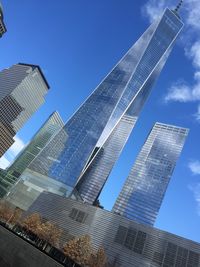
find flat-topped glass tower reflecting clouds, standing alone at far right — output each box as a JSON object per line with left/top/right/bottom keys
{"left": 113, "top": 123, "right": 188, "bottom": 225}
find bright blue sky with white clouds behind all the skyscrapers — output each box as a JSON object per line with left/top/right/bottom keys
{"left": 0, "top": 0, "right": 200, "bottom": 242}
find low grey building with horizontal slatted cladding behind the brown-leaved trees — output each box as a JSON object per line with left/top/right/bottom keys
{"left": 28, "top": 192, "right": 200, "bottom": 267}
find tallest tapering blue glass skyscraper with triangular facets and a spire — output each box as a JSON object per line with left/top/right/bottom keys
{"left": 26, "top": 9, "right": 183, "bottom": 199}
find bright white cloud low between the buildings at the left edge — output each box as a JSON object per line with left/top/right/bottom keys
{"left": 0, "top": 136, "right": 25, "bottom": 169}
